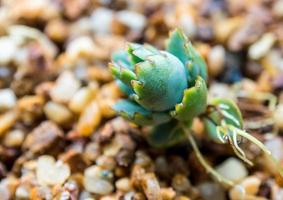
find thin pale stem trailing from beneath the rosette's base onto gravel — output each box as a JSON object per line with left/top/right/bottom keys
{"left": 182, "top": 125, "right": 234, "bottom": 187}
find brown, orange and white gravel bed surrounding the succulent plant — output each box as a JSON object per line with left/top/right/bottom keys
{"left": 0, "top": 0, "right": 283, "bottom": 200}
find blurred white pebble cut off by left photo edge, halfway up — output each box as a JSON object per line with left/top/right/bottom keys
{"left": 0, "top": 89, "right": 17, "bottom": 112}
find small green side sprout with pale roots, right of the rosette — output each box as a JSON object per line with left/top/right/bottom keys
{"left": 203, "top": 99, "right": 283, "bottom": 176}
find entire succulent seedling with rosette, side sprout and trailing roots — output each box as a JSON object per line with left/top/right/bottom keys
{"left": 110, "top": 29, "right": 283, "bottom": 185}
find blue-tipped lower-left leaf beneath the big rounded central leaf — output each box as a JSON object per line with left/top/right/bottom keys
{"left": 113, "top": 100, "right": 171, "bottom": 125}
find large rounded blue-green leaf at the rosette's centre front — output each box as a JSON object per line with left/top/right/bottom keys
{"left": 132, "top": 51, "right": 187, "bottom": 111}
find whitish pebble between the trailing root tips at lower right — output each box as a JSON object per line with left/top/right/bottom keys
{"left": 216, "top": 158, "right": 248, "bottom": 182}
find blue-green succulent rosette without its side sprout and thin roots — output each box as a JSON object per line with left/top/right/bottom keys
{"left": 110, "top": 29, "right": 207, "bottom": 147}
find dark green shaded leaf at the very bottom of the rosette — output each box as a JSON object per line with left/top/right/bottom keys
{"left": 147, "top": 120, "right": 189, "bottom": 148}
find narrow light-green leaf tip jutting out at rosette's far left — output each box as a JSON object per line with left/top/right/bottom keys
{"left": 109, "top": 63, "right": 137, "bottom": 86}
